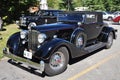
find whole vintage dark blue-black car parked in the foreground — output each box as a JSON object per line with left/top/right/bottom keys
{"left": 3, "top": 11, "right": 116, "bottom": 76}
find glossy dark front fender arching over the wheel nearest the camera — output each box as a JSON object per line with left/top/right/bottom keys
{"left": 35, "top": 38, "right": 71, "bottom": 59}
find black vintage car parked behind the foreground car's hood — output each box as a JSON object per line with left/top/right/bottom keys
{"left": 17, "top": 10, "right": 62, "bottom": 29}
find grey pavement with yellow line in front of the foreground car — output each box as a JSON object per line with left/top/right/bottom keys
{"left": 0, "top": 22, "right": 120, "bottom": 80}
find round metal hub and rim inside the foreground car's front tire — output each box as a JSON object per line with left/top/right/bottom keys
{"left": 50, "top": 52, "right": 65, "bottom": 70}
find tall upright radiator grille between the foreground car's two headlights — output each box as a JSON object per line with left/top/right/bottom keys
{"left": 28, "top": 30, "right": 39, "bottom": 52}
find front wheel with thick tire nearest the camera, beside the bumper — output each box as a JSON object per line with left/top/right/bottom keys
{"left": 45, "top": 47, "right": 69, "bottom": 76}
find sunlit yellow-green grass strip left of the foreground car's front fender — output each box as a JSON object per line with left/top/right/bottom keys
{"left": 0, "top": 24, "right": 20, "bottom": 59}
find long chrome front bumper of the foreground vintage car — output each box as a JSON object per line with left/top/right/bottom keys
{"left": 3, "top": 48, "right": 45, "bottom": 73}
